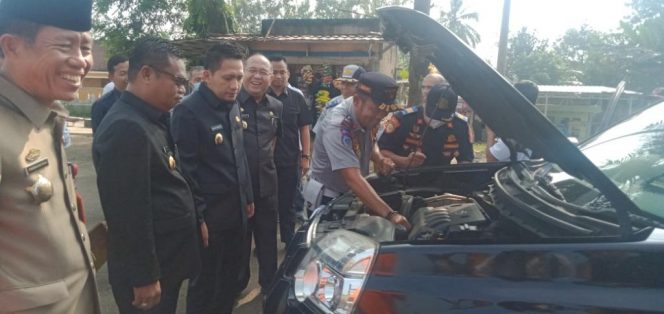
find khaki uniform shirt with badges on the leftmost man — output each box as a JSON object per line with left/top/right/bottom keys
{"left": 0, "top": 75, "right": 100, "bottom": 314}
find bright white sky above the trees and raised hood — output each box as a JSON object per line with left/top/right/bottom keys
{"left": 431, "top": 0, "right": 631, "bottom": 64}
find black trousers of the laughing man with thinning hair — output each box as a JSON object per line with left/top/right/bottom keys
{"left": 240, "top": 195, "right": 278, "bottom": 292}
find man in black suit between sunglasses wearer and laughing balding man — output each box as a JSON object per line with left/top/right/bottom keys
{"left": 172, "top": 43, "right": 254, "bottom": 314}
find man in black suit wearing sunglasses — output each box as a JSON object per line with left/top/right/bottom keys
{"left": 92, "top": 38, "right": 200, "bottom": 313}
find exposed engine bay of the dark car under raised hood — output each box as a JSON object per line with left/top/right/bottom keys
{"left": 314, "top": 163, "right": 643, "bottom": 244}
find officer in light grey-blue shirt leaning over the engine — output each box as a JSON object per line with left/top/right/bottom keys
{"left": 305, "top": 72, "right": 410, "bottom": 228}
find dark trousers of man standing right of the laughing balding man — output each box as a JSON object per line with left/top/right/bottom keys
{"left": 277, "top": 166, "right": 299, "bottom": 244}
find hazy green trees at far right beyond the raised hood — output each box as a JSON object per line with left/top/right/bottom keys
{"left": 507, "top": 0, "right": 664, "bottom": 93}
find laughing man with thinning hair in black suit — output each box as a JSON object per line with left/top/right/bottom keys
{"left": 238, "top": 54, "right": 283, "bottom": 293}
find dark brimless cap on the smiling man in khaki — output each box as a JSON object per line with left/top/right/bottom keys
{"left": 0, "top": 0, "right": 92, "bottom": 32}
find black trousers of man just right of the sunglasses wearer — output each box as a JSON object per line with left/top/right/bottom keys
{"left": 187, "top": 226, "right": 244, "bottom": 314}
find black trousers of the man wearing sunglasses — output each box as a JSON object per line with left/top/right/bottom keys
{"left": 111, "top": 279, "right": 183, "bottom": 314}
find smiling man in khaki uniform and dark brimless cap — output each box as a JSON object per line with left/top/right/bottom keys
{"left": 0, "top": 0, "right": 100, "bottom": 314}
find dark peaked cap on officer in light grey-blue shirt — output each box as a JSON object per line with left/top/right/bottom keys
{"left": 357, "top": 72, "right": 401, "bottom": 112}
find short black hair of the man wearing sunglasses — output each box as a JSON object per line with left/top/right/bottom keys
{"left": 129, "top": 36, "right": 182, "bottom": 82}
